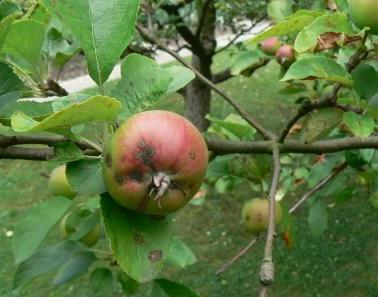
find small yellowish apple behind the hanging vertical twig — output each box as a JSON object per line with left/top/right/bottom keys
{"left": 241, "top": 198, "right": 282, "bottom": 233}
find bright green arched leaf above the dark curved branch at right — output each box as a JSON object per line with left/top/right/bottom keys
{"left": 281, "top": 56, "right": 353, "bottom": 86}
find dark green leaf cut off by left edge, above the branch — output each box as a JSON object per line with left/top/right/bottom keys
{"left": 0, "top": 62, "right": 25, "bottom": 108}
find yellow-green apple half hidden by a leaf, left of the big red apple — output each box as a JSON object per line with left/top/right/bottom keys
{"left": 47, "top": 164, "right": 76, "bottom": 199}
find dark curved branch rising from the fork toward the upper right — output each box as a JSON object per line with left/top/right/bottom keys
{"left": 278, "top": 33, "right": 368, "bottom": 143}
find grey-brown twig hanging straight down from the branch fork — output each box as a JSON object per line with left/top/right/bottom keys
{"left": 259, "top": 146, "right": 281, "bottom": 297}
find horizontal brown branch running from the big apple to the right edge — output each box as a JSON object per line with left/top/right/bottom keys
{"left": 206, "top": 136, "right": 378, "bottom": 154}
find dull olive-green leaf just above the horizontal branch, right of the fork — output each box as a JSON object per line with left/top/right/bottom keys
{"left": 304, "top": 108, "right": 343, "bottom": 143}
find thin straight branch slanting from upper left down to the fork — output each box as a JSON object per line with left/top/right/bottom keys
{"left": 136, "top": 24, "right": 276, "bottom": 139}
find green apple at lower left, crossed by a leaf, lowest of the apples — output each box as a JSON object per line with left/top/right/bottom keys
{"left": 59, "top": 208, "right": 100, "bottom": 247}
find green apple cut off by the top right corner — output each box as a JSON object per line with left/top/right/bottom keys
{"left": 348, "top": 0, "right": 378, "bottom": 35}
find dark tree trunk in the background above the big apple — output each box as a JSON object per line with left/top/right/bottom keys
{"left": 185, "top": 1, "right": 216, "bottom": 131}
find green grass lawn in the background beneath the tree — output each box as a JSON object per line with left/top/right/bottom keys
{"left": 0, "top": 51, "right": 378, "bottom": 297}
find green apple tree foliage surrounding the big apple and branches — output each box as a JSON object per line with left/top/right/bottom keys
{"left": 0, "top": 0, "right": 378, "bottom": 297}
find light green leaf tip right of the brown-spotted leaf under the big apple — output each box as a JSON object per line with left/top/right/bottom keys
{"left": 167, "top": 237, "right": 197, "bottom": 268}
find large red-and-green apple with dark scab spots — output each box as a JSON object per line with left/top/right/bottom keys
{"left": 103, "top": 110, "right": 208, "bottom": 215}
